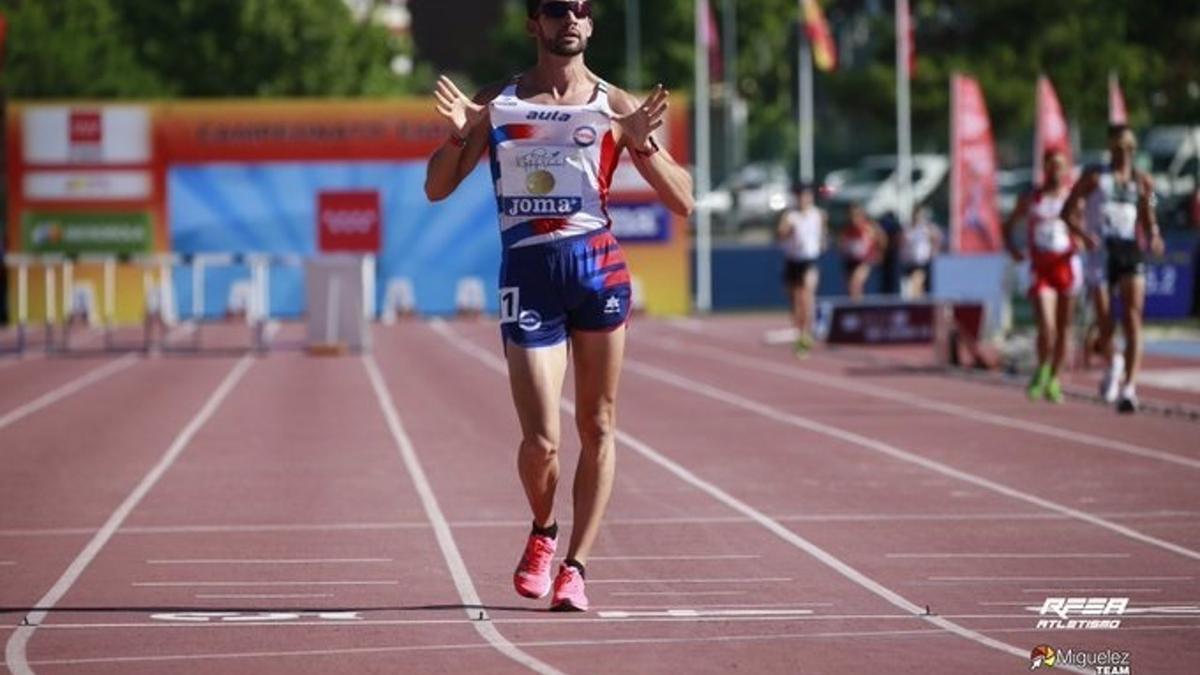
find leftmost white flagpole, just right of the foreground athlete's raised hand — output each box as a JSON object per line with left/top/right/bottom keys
{"left": 692, "top": 0, "right": 713, "bottom": 312}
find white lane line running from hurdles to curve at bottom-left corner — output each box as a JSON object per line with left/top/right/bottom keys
{"left": 5, "top": 356, "right": 254, "bottom": 675}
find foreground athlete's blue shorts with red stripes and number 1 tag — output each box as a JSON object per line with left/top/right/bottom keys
{"left": 500, "top": 229, "right": 632, "bottom": 348}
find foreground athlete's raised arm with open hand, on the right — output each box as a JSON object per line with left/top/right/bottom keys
{"left": 608, "top": 84, "right": 696, "bottom": 215}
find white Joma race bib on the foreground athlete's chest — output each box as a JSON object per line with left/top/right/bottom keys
{"left": 500, "top": 145, "right": 587, "bottom": 217}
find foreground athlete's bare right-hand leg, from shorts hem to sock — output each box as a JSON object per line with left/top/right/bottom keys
{"left": 566, "top": 327, "right": 625, "bottom": 565}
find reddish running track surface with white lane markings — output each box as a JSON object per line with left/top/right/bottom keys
{"left": 0, "top": 318, "right": 1200, "bottom": 674}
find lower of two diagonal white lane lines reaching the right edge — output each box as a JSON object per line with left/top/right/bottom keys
{"left": 625, "top": 360, "right": 1200, "bottom": 560}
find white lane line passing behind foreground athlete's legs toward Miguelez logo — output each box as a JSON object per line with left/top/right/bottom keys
{"left": 431, "top": 319, "right": 1086, "bottom": 673}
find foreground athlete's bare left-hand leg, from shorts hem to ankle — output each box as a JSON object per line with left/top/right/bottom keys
{"left": 505, "top": 342, "right": 566, "bottom": 527}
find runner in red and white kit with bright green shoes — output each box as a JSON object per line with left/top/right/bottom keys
{"left": 1004, "top": 150, "right": 1081, "bottom": 404}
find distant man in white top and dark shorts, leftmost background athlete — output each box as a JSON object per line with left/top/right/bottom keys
{"left": 778, "top": 185, "right": 829, "bottom": 356}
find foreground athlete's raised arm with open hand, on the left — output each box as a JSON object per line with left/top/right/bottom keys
{"left": 425, "top": 76, "right": 504, "bottom": 202}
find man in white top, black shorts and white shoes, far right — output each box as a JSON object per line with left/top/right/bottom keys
{"left": 1062, "top": 125, "right": 1163, "bottom": 413}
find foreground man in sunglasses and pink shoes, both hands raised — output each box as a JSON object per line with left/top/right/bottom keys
{"left": 425, "top": 0, "right": 694, "bottom": 611}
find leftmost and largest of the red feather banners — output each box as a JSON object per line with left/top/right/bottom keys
{"left": 950, "top": 74, "right": 1001, "bottom": 253}
